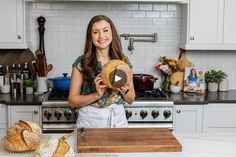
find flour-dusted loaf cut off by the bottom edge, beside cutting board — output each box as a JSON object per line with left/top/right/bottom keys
{"left": 35, "top": 139, "right": 75, "bottom": 157}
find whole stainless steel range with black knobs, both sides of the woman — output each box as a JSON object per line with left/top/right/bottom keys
{"left": 42, "top": 89, "right": 174, "bottom": 133}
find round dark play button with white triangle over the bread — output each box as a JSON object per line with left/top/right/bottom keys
{"left": 109, "top": 69, "right": 127, "bottom": 88}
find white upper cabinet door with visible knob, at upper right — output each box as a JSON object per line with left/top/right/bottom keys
{"left": 187, "top": 0, "right": 223, "bottom": 44}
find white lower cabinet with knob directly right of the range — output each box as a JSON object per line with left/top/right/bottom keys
{"left": 174, "top": 105, "right": 203, "bottom": 133}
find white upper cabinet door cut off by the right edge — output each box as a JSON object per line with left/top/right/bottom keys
{"left": 223, "top": 0, "right": 236, "bottom": 44}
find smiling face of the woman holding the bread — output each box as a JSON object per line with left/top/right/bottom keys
{"left": 91, "top": 20, "right": 112, "bottom": 49}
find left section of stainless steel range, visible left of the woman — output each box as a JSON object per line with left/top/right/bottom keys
{"left": 42, "top": 90, "right": 78, "bottom": 133}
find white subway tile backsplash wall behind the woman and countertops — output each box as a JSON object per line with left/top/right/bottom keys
{"left": 27, "top": 2, "right": 236, "bottom": 88}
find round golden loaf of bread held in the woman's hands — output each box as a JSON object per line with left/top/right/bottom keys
{"left": 101, "top": 59, "right": 132, "bottom": 89}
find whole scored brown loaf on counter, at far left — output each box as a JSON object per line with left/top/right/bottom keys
{"left": 4, "top": 121, "right": 41, "bottom": 152}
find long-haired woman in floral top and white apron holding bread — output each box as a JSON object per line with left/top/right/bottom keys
{"left": 69, "top": 15, "right": 135, "bottom": 128}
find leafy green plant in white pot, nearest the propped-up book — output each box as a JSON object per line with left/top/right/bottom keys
{"left": 205, "top": 70, "right": 227, "bottom": 92}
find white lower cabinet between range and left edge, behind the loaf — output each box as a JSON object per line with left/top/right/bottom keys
{"left": 8, "top": 105, "right": 41, "bottom": 127}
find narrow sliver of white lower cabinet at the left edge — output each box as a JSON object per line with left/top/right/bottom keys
{"left": 0, "top": 103, "right": 7, "bottom": 133}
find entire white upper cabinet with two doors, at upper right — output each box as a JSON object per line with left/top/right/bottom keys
{"left": 180, "top": 0, "right": 236, "bottom": 50}
